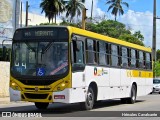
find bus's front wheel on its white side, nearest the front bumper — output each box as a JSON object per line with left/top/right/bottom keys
{"left": 81, "top": 87, "right": 95, "bottom": 110}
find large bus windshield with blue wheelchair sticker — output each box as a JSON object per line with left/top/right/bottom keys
{"left": 11, "top": 42, "right": 68, "bottom": 76}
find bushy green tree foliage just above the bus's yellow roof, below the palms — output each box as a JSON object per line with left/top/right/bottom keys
{"left": 41, "top": 19, "right": 144, "bottom": 46}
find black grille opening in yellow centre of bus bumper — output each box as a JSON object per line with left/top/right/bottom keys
{"left": 24, "top": 93, "right": 48, "bottom": 99}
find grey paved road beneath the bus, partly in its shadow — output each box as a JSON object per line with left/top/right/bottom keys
{"left": 0, "top": 94, "right": 160, "bottom": 120}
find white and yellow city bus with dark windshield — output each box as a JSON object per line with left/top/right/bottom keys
{"left": 9, "top": 26, "right": 153, "bottom": 110}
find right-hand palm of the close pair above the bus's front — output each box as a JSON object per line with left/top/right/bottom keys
{"left": 65, "top": 0, "right": 85, "bottom": 22}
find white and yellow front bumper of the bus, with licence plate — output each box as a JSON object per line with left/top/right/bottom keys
{"left": 9, "top": 87, "right": 69, "bottom": 103}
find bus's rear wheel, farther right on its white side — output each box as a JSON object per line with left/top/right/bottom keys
{"left": 128, "top": 85, "right": 137, "bottom": 104}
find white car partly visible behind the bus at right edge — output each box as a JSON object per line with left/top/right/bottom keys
{"left": 152, "top": 78, "right": 160, "bottom": 94}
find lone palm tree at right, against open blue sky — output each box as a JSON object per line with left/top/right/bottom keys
{"left": 106, "top": 0, "right": 129, "bottom": 21}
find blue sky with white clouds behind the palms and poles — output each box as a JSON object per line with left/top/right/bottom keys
{"left": 22, "top": 0, "right": 160, "bottom": 49}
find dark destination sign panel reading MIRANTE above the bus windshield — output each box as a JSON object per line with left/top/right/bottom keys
{"left": 14, "top": 27, "right": 69, "bottom": 40}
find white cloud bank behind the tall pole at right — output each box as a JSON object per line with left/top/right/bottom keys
{"left": 119, "top": 10, "right": 160, "bottom": 49}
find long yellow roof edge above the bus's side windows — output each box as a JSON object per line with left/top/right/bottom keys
{"left": 68, "top": 26, "right": 151, "bottom": 52}
